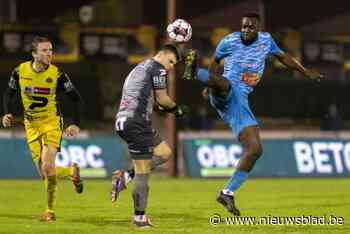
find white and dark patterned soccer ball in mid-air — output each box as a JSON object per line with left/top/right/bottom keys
{"left": 167, "top": 19, "right": 192, "bottom": 43}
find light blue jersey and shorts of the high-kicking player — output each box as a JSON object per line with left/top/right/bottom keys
{"left": 210, "top": 32, "right": 284, "bottom": 136}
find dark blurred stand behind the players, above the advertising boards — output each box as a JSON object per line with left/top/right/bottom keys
{"left": 0, "top": 0, "right": 350, "bottom": 132}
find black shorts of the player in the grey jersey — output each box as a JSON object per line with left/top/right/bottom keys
{"left": 116, "top": 117, "right": 162, "bottom": 160}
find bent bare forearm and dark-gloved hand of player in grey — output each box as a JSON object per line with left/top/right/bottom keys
{"left": 155, "top": 89, "right": 185, "bottom": 116}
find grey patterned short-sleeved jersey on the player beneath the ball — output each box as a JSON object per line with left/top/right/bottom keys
{"left": 116, "top": 59, "right": 167, "bottom": 120}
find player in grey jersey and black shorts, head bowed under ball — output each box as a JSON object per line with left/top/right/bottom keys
{"left": 111, "top": 44, "right": 184, "bottom": 227}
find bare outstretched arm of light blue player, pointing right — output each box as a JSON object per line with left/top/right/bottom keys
{"left": 276, "top": 53, "right": 323, "bottom": 79}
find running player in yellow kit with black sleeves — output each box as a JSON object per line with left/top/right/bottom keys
{"left": 2, "top": 37, "right": 83, "bottom": 221}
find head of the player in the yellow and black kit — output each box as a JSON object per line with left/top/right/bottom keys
{"left": 31, "top": 37, "right": 53, "bottom": 66}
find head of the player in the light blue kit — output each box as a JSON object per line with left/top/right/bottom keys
{"left": 241, "top": 13, "right": 260, "bottom": 43}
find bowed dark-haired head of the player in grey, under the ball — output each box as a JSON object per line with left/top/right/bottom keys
{"left": 153, "top": 44, "right": 181, "bottom": 70}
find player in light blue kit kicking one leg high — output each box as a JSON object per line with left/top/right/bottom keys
{"left": 184, "top": 13, "right": 322, "bottom": 215}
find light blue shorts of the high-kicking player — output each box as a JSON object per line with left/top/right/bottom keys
{"left": 209, "top": 83, "right": 258, "bottom": 137}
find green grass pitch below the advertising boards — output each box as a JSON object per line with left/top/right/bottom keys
{"left": 0, "top": 176, "right": 350, "bottom": 234}
